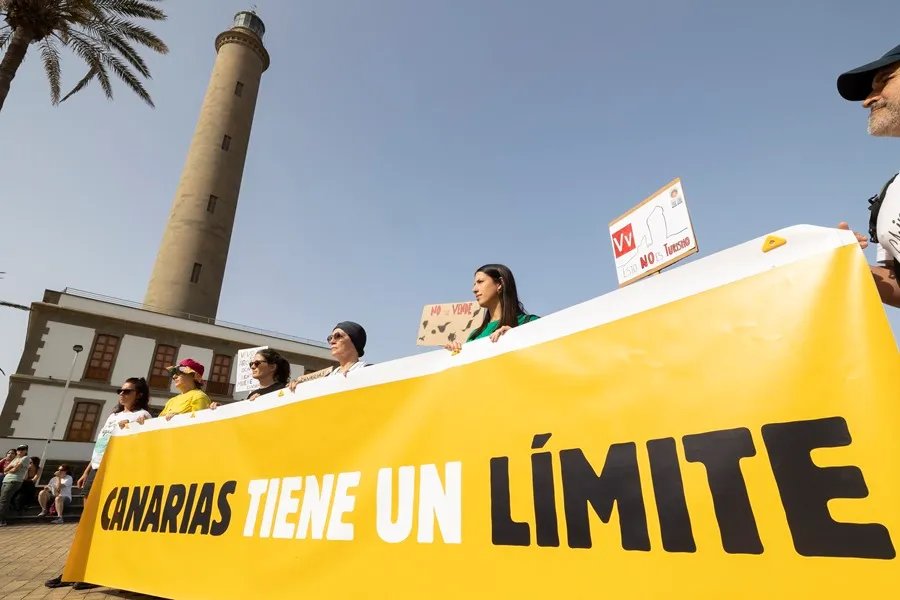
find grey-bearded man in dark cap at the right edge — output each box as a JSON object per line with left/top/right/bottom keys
{"left": 837, "top": 46, "right": 900, "bottom": 307}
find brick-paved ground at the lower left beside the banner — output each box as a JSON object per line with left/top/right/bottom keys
{"left": 0, "top": 523, "right": 163, "bottom": 600}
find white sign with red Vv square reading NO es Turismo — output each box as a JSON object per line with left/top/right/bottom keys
{"left": 609, "top": 178, "right": 699, "bottom": 287}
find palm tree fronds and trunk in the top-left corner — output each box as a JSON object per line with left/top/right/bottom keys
{"left": 0, "top": 0, "right": 169, "bottom": 110}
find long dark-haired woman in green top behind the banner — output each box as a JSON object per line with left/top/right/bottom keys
{"left": 444, "top": 264, "right": 540, "bottom": 352}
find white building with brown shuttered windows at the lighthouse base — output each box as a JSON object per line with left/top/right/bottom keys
{"left": 0, "top": 288, "right": 335, "bottom": 473}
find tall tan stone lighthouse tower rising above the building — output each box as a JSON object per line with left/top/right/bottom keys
{"left": 144, "top": 11, "right": 269, "bottom": 318}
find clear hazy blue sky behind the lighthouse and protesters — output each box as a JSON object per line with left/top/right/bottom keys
{"left": 0, "top": 0, "right": 900, "bottom": 399}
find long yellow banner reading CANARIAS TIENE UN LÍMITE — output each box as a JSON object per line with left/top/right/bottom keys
{"left": 65, "top": 227, "right": 900, "bottom": 599}
